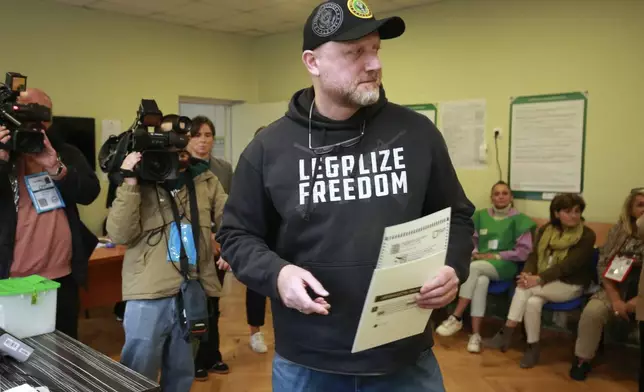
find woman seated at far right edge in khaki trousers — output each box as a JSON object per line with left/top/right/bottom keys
{"left": 570, "top": 189, "right": 644, "bottom": 381}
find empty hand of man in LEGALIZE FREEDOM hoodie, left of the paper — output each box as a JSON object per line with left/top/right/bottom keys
{"left": 277, "top": 264, "right": 331, "bottom": 316}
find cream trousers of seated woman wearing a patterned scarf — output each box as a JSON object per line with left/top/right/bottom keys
{"left": 508, "top": 280, "right": 583, "bottom": 344}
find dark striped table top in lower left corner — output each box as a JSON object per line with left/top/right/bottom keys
{"left": 0, "top": 331, "right": 161, "bottom": 392}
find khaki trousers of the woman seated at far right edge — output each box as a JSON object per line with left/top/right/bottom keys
{"left": 575, "top": 290, "right": 614, "bottom": 359}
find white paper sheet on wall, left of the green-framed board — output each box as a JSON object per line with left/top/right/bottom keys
{"left": 439, "top": 99, "right": 487, "bottom": 169}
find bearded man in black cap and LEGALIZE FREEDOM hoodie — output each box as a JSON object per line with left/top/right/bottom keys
{"left": 217, "top": 0, "right": 474, "bottom": 392}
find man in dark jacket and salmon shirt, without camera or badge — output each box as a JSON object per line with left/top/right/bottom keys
{"left": 0, "top": 88, "right": 100, "bottom": 339}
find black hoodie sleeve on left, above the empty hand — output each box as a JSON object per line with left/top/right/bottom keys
{"left": 217, "top": 141, "right": 289, "bottom": 298}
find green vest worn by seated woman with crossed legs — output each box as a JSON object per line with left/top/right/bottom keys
{"left": 472, "top": 208, "right": 537, "bottom": 280}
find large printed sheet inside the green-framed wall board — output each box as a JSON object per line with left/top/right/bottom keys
{"left": 510, "top": 94, "right": 586, "bottom": 192}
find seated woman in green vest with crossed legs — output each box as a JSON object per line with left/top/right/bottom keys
{"left": 436, "top": 181, "right": 536, "bottom": 353}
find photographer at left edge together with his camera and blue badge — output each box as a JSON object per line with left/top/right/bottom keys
{"left": 0, "top": 86, "right": 100, "bottom": 338}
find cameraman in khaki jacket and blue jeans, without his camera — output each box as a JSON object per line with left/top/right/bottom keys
{"left": 107, "top": 125, "right": 227, "bottom": 392}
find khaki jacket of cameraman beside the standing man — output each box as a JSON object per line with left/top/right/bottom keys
{"left": 107, "top": 171, "right": 227, "bottom": 301}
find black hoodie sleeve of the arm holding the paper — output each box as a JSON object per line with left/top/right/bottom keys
{"left": 423, "top": 124, "right": 475, "bottom": 283}
